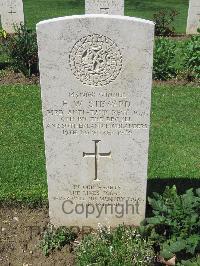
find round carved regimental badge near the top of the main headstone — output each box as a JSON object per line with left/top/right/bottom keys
{"left": 69, "top": 34, "right": 122, "bottom": 86}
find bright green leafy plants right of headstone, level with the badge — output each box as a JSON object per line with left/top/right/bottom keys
{"left": 153, "top": 35, "right": 200, "bottom": 81}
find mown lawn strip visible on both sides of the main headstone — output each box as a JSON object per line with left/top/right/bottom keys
{"left": 0, "top": 85, "right": 200, "bottom": 202}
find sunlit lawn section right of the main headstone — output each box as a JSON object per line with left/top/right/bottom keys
{"left": 148, "top": 86, "right": 200, "bottom": 178}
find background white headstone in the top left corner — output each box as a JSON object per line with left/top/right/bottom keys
{"left": 0, "top": 0, "right": 24, "bottom": 33}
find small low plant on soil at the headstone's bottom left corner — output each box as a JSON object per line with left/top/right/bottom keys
{"left": 40, "top": 224, "right": 77, "bottom": 256}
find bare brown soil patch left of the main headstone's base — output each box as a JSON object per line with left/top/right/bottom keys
{"left": 0, "top": 207, "right": 75, "bottom": 266}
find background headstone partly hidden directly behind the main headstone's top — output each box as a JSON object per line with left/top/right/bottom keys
{"left": 85, "top": 0, "right": 124, "bottom": 16}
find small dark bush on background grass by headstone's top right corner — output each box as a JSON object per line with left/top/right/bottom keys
{"left": 153, "top": 8, "right": 179, "bottom": 36}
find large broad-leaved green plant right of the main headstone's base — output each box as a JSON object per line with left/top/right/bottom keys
{"left": 143, "top": 186, "right": 200, "bottom": 261}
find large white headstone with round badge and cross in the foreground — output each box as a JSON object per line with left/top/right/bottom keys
{"left": 37, "top": 15, "right": 154, "bottom": 228}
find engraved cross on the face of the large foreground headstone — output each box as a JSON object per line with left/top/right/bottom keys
{"left": 83, "top": 140, "right": 111, "bottom": 181}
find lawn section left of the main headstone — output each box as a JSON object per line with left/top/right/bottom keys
{"left": 0, "top": 86, "right": 47, "bottom": 204}
